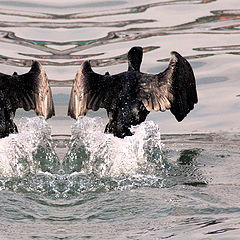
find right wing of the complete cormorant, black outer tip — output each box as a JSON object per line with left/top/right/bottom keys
{"left": 138, "top": 52, "right": 198, "bottom": 121}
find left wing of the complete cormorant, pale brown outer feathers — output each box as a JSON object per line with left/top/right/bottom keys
{"left": 68, "top": 61, "right": 122, "bottom": 119}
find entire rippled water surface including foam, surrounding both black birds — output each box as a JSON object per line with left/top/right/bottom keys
{"left": 0, "top": 0, "right": 240, "bottom": 240}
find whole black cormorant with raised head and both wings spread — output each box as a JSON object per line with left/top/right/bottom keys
{"left": 68, "top": 47, "right": 198, "bottom": 138}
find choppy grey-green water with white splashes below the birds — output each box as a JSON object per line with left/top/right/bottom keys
{"left": 0, "top": 118, "right": 240, "bottom": 239}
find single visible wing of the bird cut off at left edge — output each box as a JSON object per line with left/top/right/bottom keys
{"left": 0, "top": 61, "right": 55, "bottom": 119}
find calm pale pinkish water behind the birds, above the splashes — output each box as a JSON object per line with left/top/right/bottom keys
{"left": 0, "top": 0, "right": 240, "bottom": 134}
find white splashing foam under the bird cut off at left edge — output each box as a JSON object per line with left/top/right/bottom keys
{"left": 0, "top": 117, "right": 51, "bottom": 177}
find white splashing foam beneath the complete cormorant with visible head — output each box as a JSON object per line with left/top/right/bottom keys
{"left": 70, "top": 117, "right": 162, "bottom": 177}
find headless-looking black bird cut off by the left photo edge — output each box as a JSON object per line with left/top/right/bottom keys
{"left": 0, "top": 61, "right": 55, "bottom": 138}
